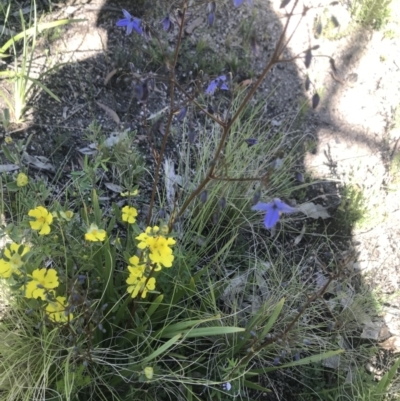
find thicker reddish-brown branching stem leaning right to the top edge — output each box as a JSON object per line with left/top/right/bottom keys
{"left": 176, "top": 0, "right": 299, "bottom": 217}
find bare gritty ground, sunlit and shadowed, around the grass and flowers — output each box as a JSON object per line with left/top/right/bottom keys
{"left": 0, "top": 0, "right": 400, "bottom": 390}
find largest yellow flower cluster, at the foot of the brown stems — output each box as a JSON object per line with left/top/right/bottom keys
{"left": 126, "top": 226, "right": 175, "bottom": 298}
